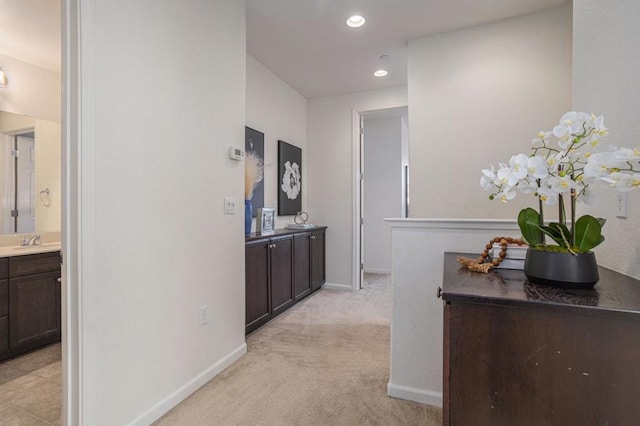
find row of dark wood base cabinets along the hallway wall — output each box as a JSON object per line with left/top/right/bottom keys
{"left": 245, "top": 227, "right": 326, "bottom": 334}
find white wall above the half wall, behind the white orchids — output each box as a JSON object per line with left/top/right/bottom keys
{"left": 408, "top": 6, "right": 572, "bottom": 218}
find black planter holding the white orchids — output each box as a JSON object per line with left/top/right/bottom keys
{"left": 524, "top": 248, "right": 600, "bottom": 289}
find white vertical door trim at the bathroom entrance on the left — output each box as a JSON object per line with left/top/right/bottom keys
{"left": 61, "top": 0, "right": 90, "bottom": 425}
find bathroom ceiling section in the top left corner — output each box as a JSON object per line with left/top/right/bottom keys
{"left": 0, "top": 0, "right": 62, "bottom": 73}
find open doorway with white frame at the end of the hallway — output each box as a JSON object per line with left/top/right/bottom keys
{"left": 354, "top": 106, "right": 409, "bottom": 290}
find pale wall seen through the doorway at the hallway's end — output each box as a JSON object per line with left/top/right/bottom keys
{"left": 363, "top": 116, "right": 403, "bottom": 273}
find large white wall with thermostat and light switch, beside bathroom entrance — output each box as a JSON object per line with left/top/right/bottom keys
{"left": 68, "top": 0, "right": 246, "bottom": 425}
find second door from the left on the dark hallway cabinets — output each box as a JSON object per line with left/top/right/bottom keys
{"left": 270, "top": 236, "right": 293, "bottom": 315}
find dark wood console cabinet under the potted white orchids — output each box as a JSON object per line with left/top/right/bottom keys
{"left": 441, "top": 253, "right": 640, "bottom": 426}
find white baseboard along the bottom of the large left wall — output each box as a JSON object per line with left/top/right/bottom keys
{"left": 129, "top": 343, "right": 247, "bottom": 425}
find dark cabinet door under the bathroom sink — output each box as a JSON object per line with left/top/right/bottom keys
{"left": 9, "top": 271, "right": 60, "bottom": 354}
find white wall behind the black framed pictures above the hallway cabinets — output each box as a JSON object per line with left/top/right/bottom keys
{"left": 246, "top": 55, "right": 308, "bottom": 231}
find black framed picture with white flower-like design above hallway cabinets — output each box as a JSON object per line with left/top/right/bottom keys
{"left": 277, "top": 140, "right": 302, "bottom": 216}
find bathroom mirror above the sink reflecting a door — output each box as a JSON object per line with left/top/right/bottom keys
{"left": 0, "top": 111, "right": 62, "bottom": 234}
